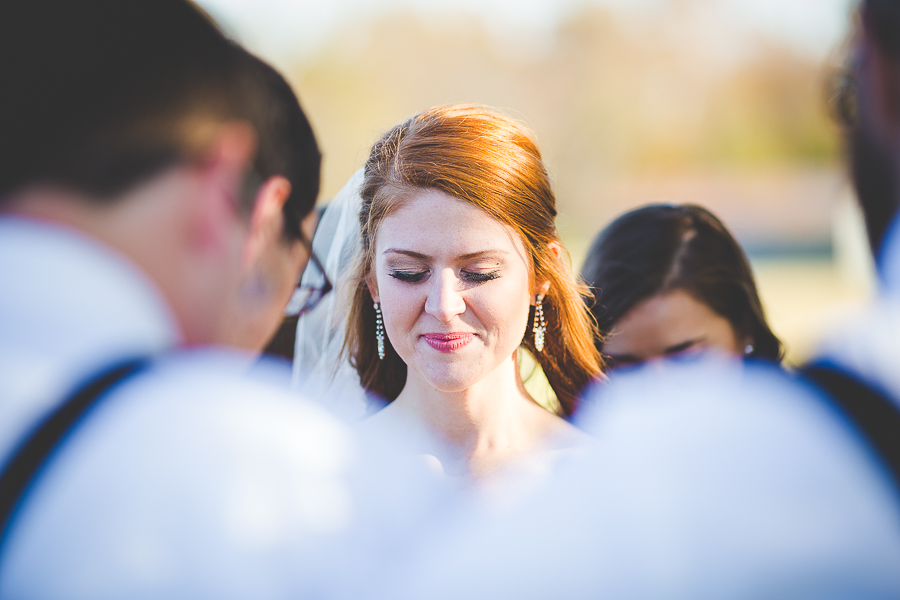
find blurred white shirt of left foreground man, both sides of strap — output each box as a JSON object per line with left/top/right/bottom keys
{"left": 0, "top": 217, "right": 446, "bottom": 600}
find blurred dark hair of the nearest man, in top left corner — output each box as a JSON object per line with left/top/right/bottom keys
{"left": 0, "top": 0, "right": 298, "bottom": 216}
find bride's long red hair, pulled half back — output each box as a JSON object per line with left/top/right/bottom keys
{"left": 345, "top": 105, "right": 603, "bottom": 415}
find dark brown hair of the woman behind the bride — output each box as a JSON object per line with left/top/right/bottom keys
{"left": 581, "top": 204, "right": 784, "bottom": 361}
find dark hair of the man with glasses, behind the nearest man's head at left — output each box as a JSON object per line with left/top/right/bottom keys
{"left": 239, "top": 49, "right": 322, "bottom": 240}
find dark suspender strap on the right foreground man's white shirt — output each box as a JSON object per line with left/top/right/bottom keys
{"left": 800, "top": 363, "right": 900, "bottom": 491}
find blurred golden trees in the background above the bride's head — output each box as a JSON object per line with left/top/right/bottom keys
{"left": 289, "top": 7, "right": 838, "bottom": 206}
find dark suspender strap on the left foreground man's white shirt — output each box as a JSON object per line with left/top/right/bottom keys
{"left": 0, "top": 358, "right": 150, "bottom": 547}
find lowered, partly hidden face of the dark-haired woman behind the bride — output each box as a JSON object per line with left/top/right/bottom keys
{"left": 603, "top": 290, "right": 749, "bottom": 367}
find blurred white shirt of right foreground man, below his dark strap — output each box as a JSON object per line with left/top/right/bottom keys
{"left": 381, "top": 358, "right": 900, "bottom": 600}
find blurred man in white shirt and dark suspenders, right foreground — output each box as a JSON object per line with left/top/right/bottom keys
{"left": 385, "top": 0, "right": 900, "bottom": 600}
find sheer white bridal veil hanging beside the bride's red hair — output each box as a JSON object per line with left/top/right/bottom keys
{"left": 292, "top": 169, "right": 375, "bottom": 420}
